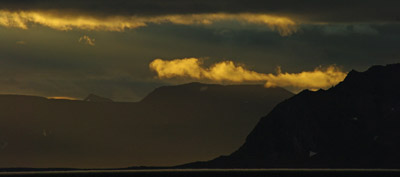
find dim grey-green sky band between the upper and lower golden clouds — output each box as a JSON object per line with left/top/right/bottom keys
{"left": 0, "top": 19, "right": 400, "bottom": 101}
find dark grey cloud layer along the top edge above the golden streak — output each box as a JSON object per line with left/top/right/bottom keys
{"left": 0, "top": 0, "right": 400, "bottom": 23}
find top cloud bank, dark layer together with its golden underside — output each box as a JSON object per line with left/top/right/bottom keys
{"left": 0, "top": 0, "right": 400, "bottom": 36}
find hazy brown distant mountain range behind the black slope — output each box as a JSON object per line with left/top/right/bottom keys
{"left": 0, "top": 83, "right": 293, "bottom": 168}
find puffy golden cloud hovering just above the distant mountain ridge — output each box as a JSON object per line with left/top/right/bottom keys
{"left": 149, "top": 58, "right": 347, "bottom": 89}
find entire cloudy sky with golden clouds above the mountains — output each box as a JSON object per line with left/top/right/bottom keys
{"left": 0, "top": 0, "right": 400, "bottom": 101}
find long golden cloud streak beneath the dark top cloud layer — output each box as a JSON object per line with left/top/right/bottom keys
{"left": 0, "top": 10, "right": 297, "bottom": 36}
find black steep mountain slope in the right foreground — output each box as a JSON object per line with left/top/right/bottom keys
{"left": 180, "top": 64, "right": 400, "bottom": 168}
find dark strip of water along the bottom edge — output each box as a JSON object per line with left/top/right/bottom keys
{"left": 0, "top": 169, "right": 400, "bottom": 177}
